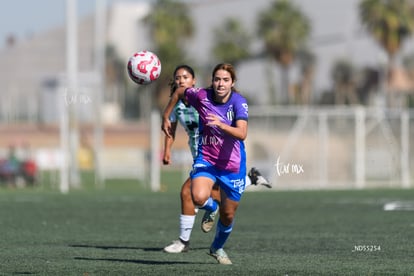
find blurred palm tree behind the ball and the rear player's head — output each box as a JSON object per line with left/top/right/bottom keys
{"left": 144, "top": 0, "right": 194, "bottom": 108}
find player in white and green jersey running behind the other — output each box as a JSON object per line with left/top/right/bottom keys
{"left": 163, "top": 65, "right": 271, "bottom": 253}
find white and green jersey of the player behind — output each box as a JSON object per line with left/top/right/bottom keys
{"left": 170, "top": 100, "right": 199, "bottom": 159}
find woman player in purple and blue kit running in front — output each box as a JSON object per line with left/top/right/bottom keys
{"left": 162, "top": 64, "right": 258, "bottom": 264}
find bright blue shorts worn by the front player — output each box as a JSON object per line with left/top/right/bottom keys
{"left": 190, "top": 159, "right": 246, "bottom": 202}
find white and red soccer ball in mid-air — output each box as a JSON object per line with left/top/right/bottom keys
{"left": 127, "top": 50, "right": 161, "bottom": 84}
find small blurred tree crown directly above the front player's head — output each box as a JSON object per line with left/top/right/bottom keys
{"left": 212, "top": 18, "right": 251, "bottom": 66}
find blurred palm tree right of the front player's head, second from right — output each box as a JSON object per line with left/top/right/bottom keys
{"left": 258, "top": 0, "right": 310, "bottom": 102}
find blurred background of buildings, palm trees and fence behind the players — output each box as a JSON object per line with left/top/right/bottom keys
{"left": 0, "top": 0, "right": 414, "bottom": 192}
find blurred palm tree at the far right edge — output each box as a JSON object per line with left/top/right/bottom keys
{"left": 359, "top": 0, "right": 414, "bottom": 103}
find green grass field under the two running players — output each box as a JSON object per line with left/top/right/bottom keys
{"left": 0, "top": 174, "right": 414, "bottom": 275}
